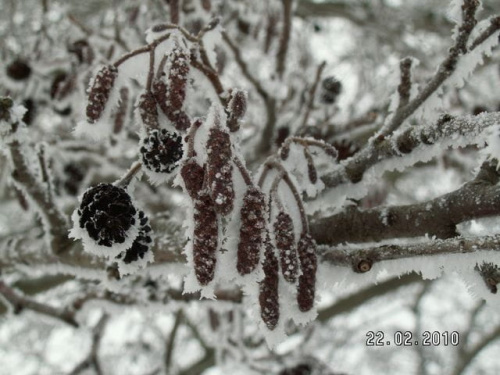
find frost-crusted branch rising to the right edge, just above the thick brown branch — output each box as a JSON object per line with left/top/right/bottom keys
{"left": 322, "top": 112, "right": 500, "bottom": 188}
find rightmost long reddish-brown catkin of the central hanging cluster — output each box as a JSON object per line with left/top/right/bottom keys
{"left": 297, "top": 234, "right": 318, "bottom": 312}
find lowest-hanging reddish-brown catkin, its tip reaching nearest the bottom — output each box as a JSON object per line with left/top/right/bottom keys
{"left": 259, "top": 233, "right": 280, "bottom": 330}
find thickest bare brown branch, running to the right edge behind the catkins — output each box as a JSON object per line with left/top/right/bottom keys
{"left": 311, "top": 157, "right": 500, "bottom": 245}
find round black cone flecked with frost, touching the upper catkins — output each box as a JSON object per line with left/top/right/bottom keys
{"left": 140, "top": 129, "right": 183, "bottom": 173}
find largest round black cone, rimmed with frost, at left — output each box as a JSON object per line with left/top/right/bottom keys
{"left": 78, "top": 184, "right": 136, "bottom": 247}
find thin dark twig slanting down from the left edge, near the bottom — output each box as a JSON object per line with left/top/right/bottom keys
{"left": 0, "top": 280, "right": 79, "bottom": 327}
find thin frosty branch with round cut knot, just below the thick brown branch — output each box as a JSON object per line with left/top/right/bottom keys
{"left": 320, "top": 235, "right": 500, "bottom": 273}
